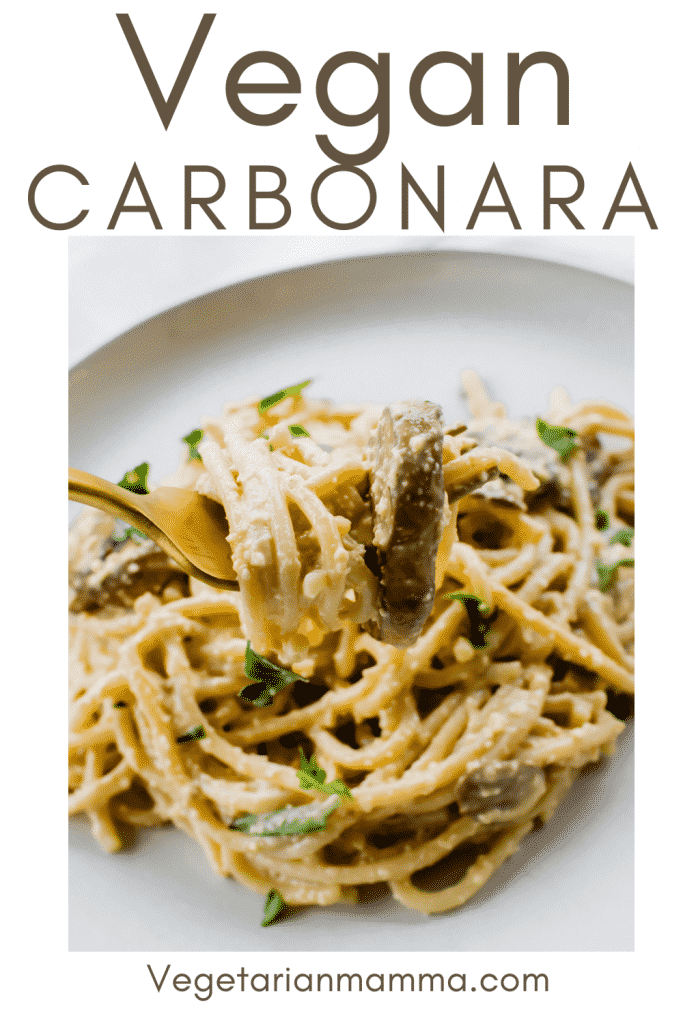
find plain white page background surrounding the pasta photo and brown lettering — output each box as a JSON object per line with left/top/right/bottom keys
{"left": 2, "top": 0, "right": 681, "bottom": 1021}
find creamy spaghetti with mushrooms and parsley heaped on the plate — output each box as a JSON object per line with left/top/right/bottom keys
{"left": 70, "top": 371, "right": 634, "bottom": 924}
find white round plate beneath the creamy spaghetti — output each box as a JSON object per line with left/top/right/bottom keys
{"left": 70, "top": 245, "right": 633, "bottom": 952}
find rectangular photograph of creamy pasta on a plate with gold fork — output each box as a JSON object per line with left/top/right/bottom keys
{"left": 69, "top": 236, "right": 635, "bottom": 951}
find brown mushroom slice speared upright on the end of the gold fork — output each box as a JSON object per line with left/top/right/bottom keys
{"left": 370, "top": 401, "right": 443, "bottom": 647}
